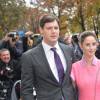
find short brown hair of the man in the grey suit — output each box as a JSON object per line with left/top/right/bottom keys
{"left": 39, "top": 14, "right": 59, "bottom": 28}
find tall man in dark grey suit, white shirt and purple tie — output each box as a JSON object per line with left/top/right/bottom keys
{"left": 21, "top": 15, "right": 75, "bottom": 100}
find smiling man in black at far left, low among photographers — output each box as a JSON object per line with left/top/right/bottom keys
{"left": 0, "top": 49, "right": 21, "bottom": 100}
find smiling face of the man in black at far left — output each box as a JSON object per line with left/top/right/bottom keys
{"left": 0, "top": 51, "right": 10, "bottom": 63}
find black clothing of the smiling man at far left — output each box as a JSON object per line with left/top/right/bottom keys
{"left": 0, "top": 60, "right": 21, "bottom": 100}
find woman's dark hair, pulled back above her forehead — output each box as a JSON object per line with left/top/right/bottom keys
{"left": 79, "top": 31, "right": 97, "bottom": 44}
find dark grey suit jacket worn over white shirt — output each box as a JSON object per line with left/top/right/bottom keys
{"left": 21, "top": 43, "right": 75, "bottom": 100}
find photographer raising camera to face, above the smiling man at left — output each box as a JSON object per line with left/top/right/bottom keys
{"left": 0, "top": 32, "right": 23, "bottom": 59}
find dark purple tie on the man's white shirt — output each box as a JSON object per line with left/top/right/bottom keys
{"left": 51, "top": 48, "right": 64, "bottom": 84}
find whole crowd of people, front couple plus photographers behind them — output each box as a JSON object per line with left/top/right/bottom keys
{"left": 0, "top": 15, "right": 100, "bottom": 100}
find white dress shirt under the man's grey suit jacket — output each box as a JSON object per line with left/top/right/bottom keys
{"left": 42, "top": 41, "right": 67, "bottom": 81}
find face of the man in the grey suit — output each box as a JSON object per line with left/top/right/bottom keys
{"left": 40, "top": 20, "right": 59, "bottom": 46}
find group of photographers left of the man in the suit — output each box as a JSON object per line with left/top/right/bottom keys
{"left": 0, "top": 31, "right": 42, "bottom": 100}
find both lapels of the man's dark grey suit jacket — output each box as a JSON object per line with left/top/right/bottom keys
{"left": 35, "top": 43, "right": 72, "bottom": 85}
